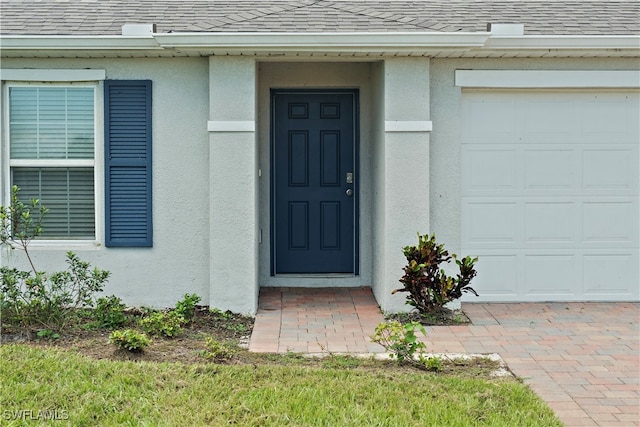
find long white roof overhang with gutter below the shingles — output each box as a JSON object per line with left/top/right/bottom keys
{"left": 0, "top": 32, "right": 640, "bottom": 57}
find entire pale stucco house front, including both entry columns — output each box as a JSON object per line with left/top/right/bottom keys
{"left": 0, "top": 42, "right": 640, "bottom": 313}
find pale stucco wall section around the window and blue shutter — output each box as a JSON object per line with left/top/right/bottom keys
{"left": 0, "top": 58, "right": 209, "bottom": 307}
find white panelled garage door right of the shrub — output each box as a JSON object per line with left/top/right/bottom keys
{"left": 461, "top": 91, "right": 640, "bottom": 301}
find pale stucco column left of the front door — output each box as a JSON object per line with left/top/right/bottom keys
{"left": 210, "top": 57, "right": 259, "bottom": 314}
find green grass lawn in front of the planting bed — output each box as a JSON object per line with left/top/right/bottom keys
{"left": 0, "top": 344, "right": 561, "bottom": 427}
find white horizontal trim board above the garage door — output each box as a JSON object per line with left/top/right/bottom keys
{"left": 455, "top": 70, "right": 640, "bottom": 89}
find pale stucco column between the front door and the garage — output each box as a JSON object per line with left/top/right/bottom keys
{"left": 374, "top": 58, "right": 432, "bottom": 312}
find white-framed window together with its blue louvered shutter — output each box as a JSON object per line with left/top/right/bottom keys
{"left": 0, "top": 75, "right": 153, "bottom": 247}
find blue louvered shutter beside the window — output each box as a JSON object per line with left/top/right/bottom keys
{"left": 104, "top": 80, "right": 153, "bottom": 247}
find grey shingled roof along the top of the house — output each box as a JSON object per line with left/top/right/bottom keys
{"left": 0, "top": 0, "right": 640, "bottom": 36}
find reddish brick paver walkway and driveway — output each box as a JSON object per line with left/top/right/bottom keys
{"left": 250, "top": 288, "right": 640, "bottom": 427}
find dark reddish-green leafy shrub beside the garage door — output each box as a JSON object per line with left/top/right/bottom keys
{"left": 392, "top": 233, "right": 478, "bottom": 313}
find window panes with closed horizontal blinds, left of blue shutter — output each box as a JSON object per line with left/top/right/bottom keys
{"left": 5, "top": 84, "right": 97, "bottom": 240}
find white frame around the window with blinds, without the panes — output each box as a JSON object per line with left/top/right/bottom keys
{"left": 0, "top": 74, "right": 105, "bottom": 250}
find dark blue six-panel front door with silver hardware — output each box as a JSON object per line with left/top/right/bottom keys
{"left": 271, "top": 90, "right": 358, "bottom": 274}
